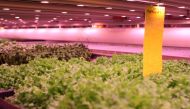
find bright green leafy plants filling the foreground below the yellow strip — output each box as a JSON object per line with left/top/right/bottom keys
{"left": 0, "top": 55, "right": 190, "bottom": 109}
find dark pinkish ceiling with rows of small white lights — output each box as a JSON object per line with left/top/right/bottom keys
{"left": 0, "top": 0, "right": 190, "bottom": 28}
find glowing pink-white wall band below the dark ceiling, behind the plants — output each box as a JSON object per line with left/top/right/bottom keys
{"left": 0, "top": 28, "right": 190, "bottom": 47}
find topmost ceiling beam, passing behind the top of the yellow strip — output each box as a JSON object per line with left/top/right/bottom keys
{"left": 50, "top": 0, "right": 185, "bottom": 14}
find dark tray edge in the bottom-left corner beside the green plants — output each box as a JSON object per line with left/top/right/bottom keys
{"left": 0, "top": 89, "right": 19, "bottom": 109}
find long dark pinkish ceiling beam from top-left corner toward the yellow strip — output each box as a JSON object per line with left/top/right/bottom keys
{"left": 0, "top": 1, "right": 143, "bottom": 16}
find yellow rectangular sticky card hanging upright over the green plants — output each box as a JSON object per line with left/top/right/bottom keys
{"left": 143, "top": 6, "right": 165, "bottom": 77}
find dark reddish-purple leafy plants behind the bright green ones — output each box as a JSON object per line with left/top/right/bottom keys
{"left": 0, "top": 42, "right": 90, "bottom": 65}
